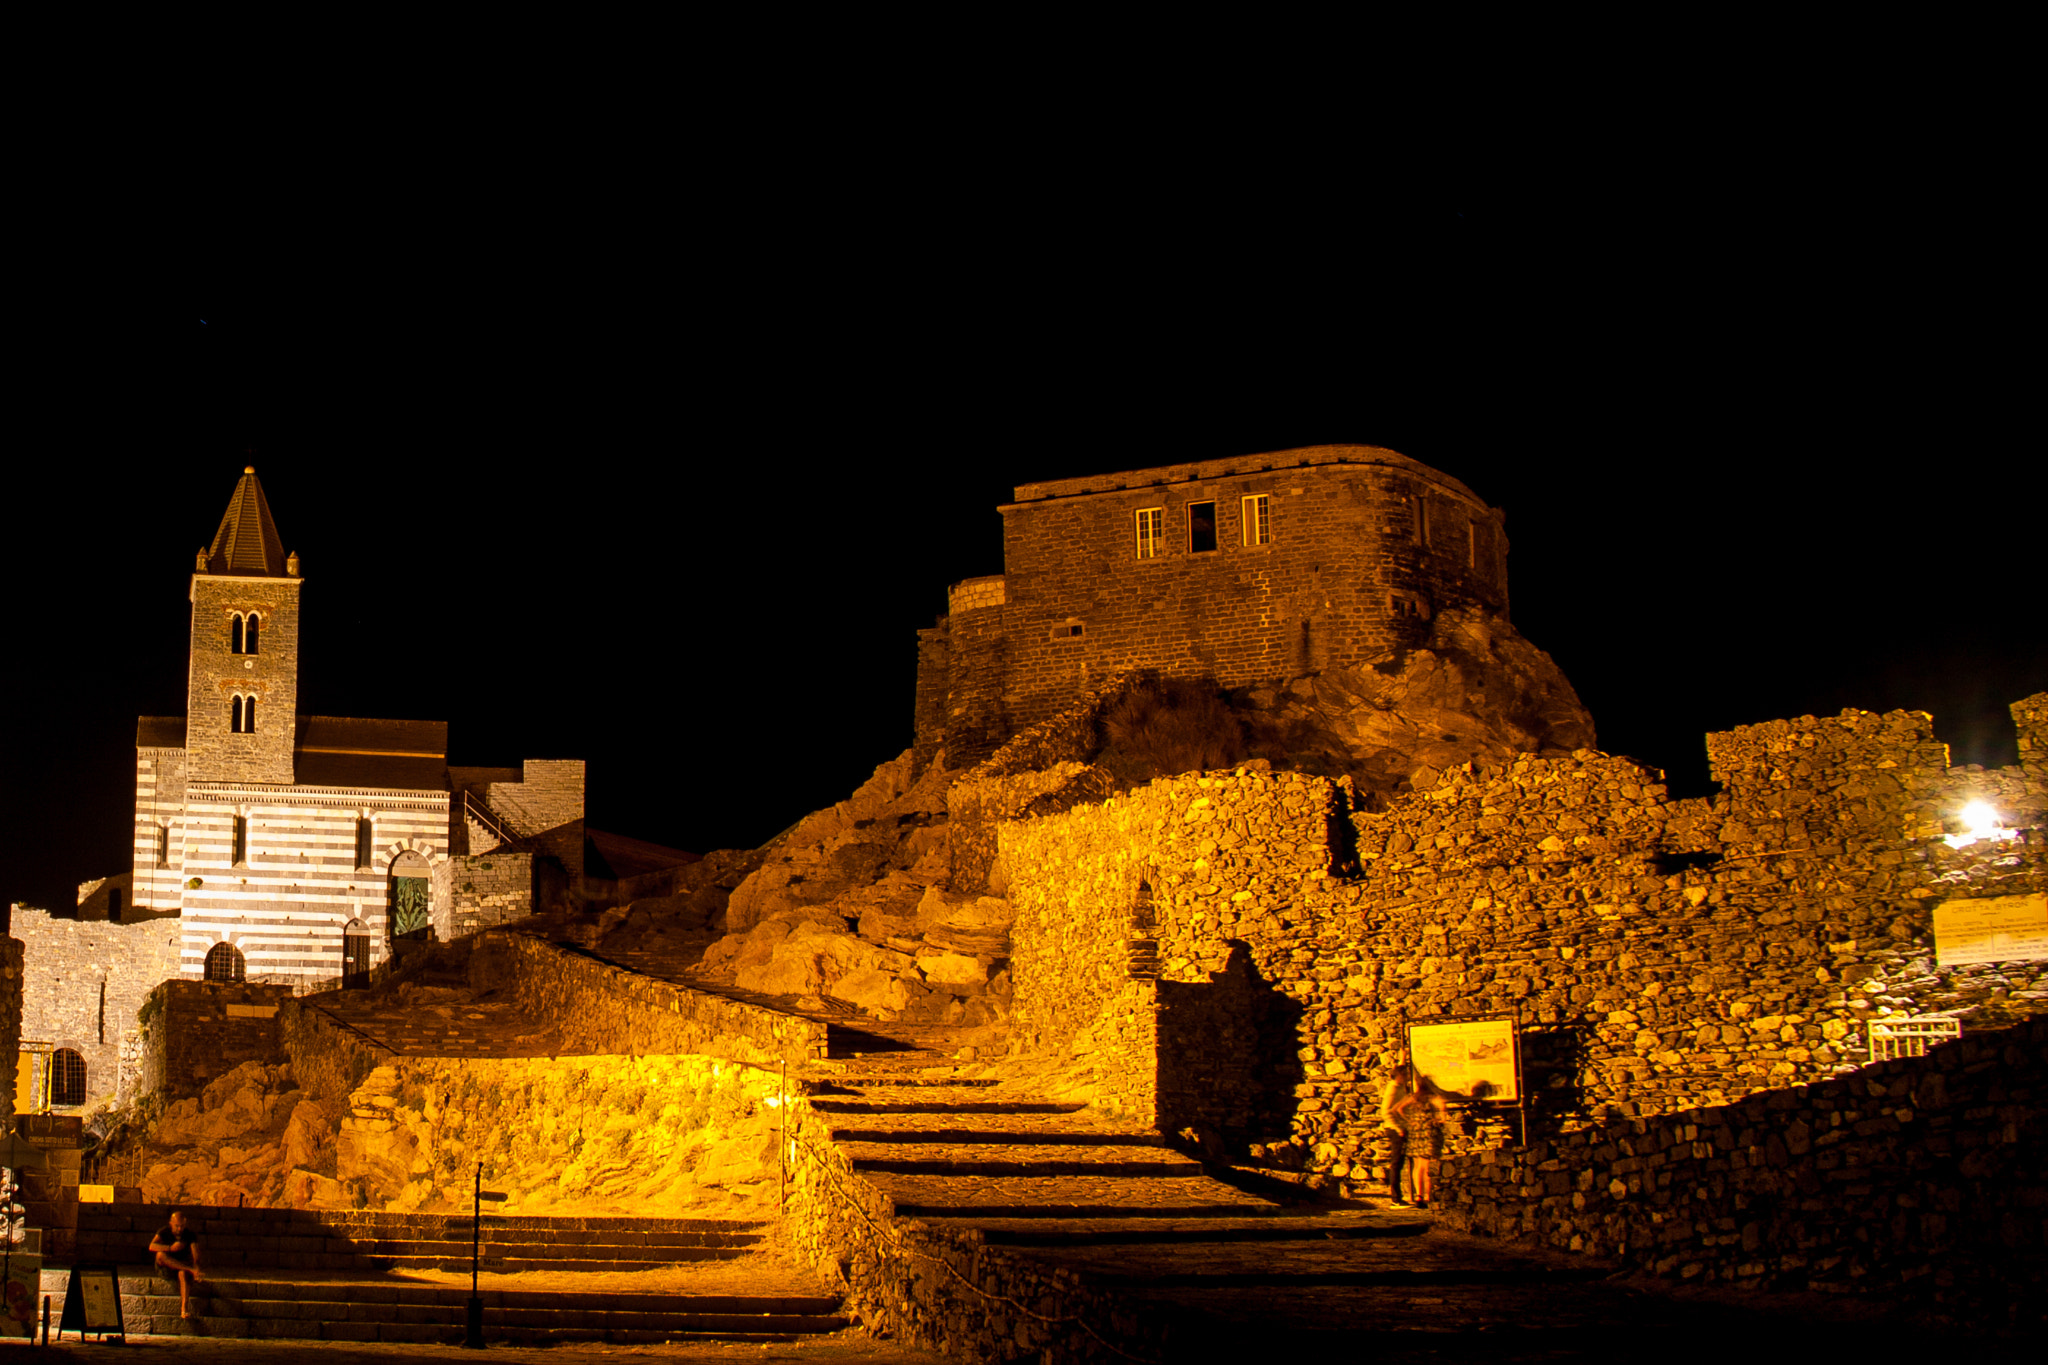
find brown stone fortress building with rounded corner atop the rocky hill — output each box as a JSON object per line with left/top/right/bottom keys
{"left": 915, "top": 446, "right": 1507, "bottom": 767}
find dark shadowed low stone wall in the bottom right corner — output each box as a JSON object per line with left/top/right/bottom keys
{"left": 1432, "top": 1021, "right": 2048, "bottom": 1326}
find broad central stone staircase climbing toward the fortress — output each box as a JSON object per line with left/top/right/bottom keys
{"left": 811, "top": 1052, "right": 1679, "bottom": 1359}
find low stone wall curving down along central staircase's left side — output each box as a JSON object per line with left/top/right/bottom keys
{"left": 784, "top": 1099, "right": 1171, "bottom": 1361}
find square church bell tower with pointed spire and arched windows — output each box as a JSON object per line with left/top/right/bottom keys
{"left": 184, "top": 469, "right": 299, "bottom": 786}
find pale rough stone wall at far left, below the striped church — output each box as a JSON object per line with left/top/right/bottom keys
{"left": 14, "top": 907, "right": 182, "bottom": 1107}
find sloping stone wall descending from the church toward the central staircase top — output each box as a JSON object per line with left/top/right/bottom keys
{"left": 483, "top": 929, "right": 825, "bottom": 1064}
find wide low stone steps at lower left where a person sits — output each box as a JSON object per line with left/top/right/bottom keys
{"left": 80, "top": 1205, "right": 846, "bottom": 1345}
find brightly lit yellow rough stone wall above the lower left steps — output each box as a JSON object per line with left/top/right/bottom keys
{"left": 335, "top": 1056, "right": 780, "bottom": 1218}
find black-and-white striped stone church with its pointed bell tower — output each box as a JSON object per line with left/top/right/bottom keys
{"left": 12, "top": 469, "right": 586, "bottom": 1107}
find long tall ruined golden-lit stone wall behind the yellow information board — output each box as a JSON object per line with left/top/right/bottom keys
{"left": 999, "top": 704, "right": 2048, "bottom": 1179}
